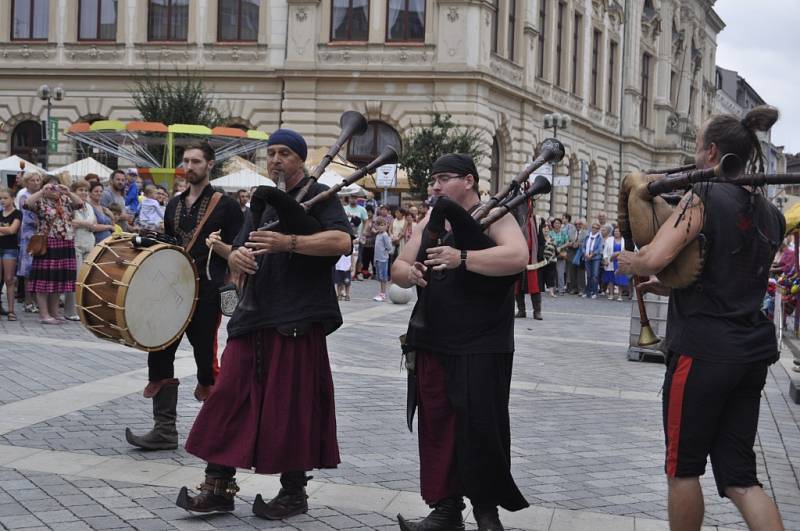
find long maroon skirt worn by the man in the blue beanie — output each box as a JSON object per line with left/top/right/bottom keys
{"left": 186, "top": 325, "right": 340, "bottom": 474}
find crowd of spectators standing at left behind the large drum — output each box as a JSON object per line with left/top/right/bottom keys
{"left": 0, "top": 169, "right": 186, "bottom": 325}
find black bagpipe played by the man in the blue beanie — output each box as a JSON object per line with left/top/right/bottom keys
{"left": 237, "top": 111, "right": 398, "bottom": 311}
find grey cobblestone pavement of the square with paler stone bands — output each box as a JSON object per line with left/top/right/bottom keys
{"left": 0, "top": 282, "right": 800, "bottom": 530}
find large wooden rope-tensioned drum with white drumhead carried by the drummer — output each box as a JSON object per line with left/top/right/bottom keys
{"left": 76, "top": 234, "right": 199, "bottom": 352}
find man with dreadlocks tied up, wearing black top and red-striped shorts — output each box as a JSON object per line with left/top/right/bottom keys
{"left": 619, "top": 106, "right": 785, "bottom": 531}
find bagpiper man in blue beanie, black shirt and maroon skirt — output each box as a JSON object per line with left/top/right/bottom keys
{"left": 177, "top": 129, "right": 352, "bottom": 520}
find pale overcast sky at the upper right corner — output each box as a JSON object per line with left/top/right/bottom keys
{"left": 714, "top": 0, "right": 800, "bottom": 153}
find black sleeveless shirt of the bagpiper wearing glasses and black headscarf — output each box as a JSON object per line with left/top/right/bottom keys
{"left": 406, "top": 227, "right": 514, "bottom": 355}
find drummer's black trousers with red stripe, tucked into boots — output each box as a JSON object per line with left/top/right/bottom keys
{"left": 147, "top": 296, "right": 222, "bottom": 385}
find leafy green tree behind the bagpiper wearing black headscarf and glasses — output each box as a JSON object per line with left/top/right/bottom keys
{"left": 400, "top": 112, "right": 483, "bottom": 197}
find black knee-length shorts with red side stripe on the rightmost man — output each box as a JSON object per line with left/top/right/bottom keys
{"left": 663, "top": 354, "right": 769, "bottom": 497}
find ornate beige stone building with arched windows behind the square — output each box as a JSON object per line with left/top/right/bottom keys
{"left": 0, "top": 0, "right": 724, "bottom": 217}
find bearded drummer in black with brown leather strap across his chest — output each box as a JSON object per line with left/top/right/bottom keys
{"left": 125, "top": 143, "right": 243, "bottom": 450}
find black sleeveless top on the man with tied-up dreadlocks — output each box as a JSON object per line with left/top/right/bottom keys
{"left": 666, "top": 183, "right": 786, "bottom": 363}
